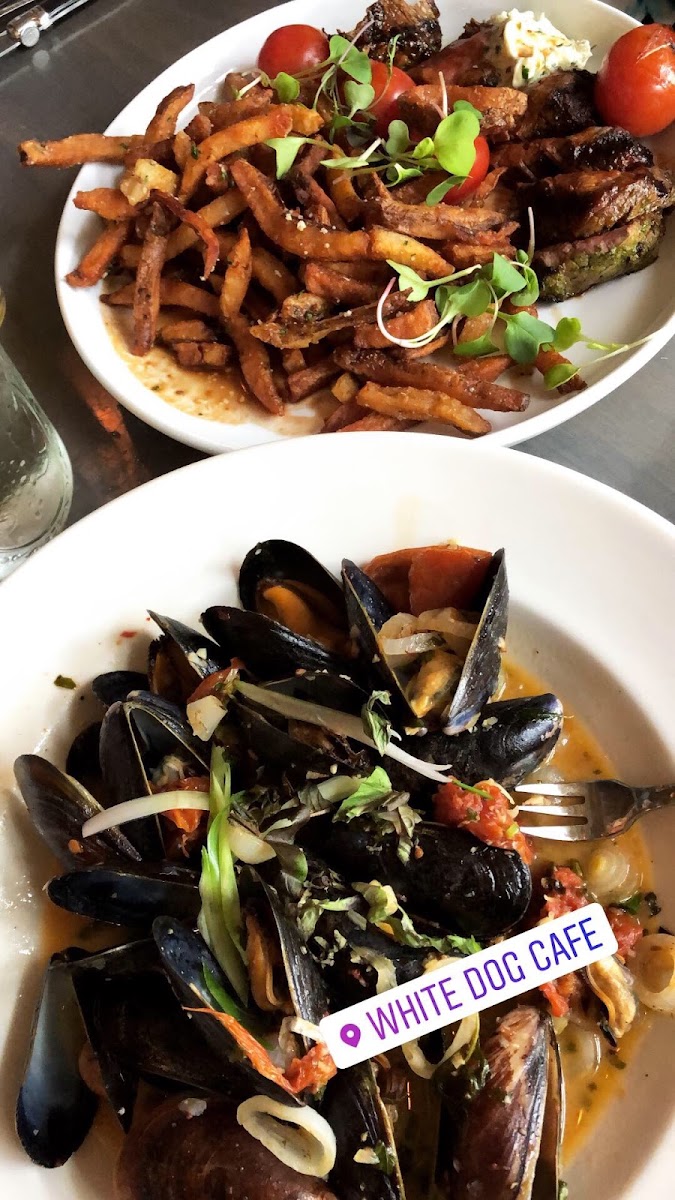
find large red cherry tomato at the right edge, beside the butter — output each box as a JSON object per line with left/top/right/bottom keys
{"left": 596, "top": 25, "right": 675, "bottom": 137}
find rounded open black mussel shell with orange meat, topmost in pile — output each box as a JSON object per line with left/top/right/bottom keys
{"left": 239, "top": 539, "right": 348, "bottom": 653}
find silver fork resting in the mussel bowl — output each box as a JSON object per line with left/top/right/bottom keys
{"left": 514, "top": 779, "right": 675, "bottom": 841}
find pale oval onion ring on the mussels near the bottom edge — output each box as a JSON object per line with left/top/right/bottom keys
{"left": 237, "top": 1096, "right": 336, "bottom": 1178}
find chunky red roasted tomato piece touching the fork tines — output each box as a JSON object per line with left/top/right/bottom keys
{"left": 434, "top": 779, "right": 532, "bottom": 863}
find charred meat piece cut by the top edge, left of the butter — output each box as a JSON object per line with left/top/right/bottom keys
{"left": 345, "top": 0, "right": 441, "bottom": 71}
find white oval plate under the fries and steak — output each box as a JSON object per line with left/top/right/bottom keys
{"left": 55, "top": 0, "right": 675, "bottom": 452}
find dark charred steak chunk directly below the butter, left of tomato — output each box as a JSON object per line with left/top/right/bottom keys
{"left": 516, "top": 71, "right": 598, "bottom": 142}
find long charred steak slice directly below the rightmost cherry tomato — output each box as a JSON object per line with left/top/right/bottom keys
{"left": 491, "top": 126, "right": 653, "bottom": 186}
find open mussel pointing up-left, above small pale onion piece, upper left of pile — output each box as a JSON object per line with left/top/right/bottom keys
{"left": 148, "top": 611, "right": 227, "bottom": 704}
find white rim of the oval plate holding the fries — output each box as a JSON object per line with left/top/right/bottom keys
{"left": 54, "top": 0, "right": 675, "bottom": 454}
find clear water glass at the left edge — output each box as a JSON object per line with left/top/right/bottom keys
{"left": 0, "top": 292, "right": 72, "bottom": 580}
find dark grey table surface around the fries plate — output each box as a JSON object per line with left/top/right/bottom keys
{"left": 0, "top": 0, "right": 675, "bottom": 521}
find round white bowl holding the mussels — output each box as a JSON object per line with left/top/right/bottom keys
{"left": 0, "top": 434, "right": 675, "bottom": 1200}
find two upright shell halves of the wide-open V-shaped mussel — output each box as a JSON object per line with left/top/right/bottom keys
{"left": 342, "top": 551, "right": 508, "bottom": 736}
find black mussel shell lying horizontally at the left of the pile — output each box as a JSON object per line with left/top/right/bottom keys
{"left": 47, "top": 864, "right": 199, "bottom": 932}
